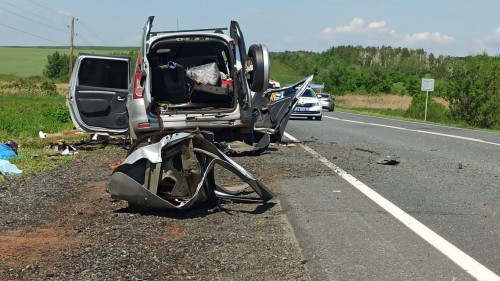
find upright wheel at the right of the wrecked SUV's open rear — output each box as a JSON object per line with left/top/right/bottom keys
{"left": 247, "top": 44, "right": 269, "bottom": 93}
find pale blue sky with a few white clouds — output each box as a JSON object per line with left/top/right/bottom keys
{"left": 0, "top": 0, "right": 500, "bottom": 56}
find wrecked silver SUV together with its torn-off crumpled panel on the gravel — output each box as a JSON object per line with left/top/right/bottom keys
{"left": 67, "top": 17, "right": 312, "bottom": 209}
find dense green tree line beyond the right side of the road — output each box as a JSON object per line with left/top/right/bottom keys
{"left": 271, "top": 46, "right": 500, "bottom": 128}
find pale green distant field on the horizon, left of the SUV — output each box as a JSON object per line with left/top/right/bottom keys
{"left": 0, "top": 47, "right": 134, "bottom": 77}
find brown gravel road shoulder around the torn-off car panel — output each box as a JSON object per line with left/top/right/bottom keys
{"left": 0, "top": 142, "right": 318, "bottom": 280}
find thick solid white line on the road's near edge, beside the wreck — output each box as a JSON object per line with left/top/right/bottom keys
{"left": 284, "top": 132, "right": 500, "bottom": 280}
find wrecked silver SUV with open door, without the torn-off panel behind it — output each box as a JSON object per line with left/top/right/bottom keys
{"left": 68, "top": 16, "right": 310, "bottom": 148}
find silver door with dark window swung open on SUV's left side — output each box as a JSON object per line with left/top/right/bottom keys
{"left": 67, "top": 54, "right": 130, "bottom": 134}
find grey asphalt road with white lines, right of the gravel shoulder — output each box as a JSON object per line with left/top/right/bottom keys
{"left": 279, "top": 112, "right": 500, "bottom": 280}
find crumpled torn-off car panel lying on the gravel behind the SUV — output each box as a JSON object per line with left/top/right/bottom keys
{"left": 107, "top": 132, "right": 274, "bottom": 210}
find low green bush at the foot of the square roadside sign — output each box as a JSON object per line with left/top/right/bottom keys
{"left": 404, "top": 93, "right": 450, "bottom": 122}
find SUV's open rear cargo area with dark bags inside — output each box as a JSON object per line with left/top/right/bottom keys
{"left": 148, "top": 35, "right": 237, "bottom": 114}
